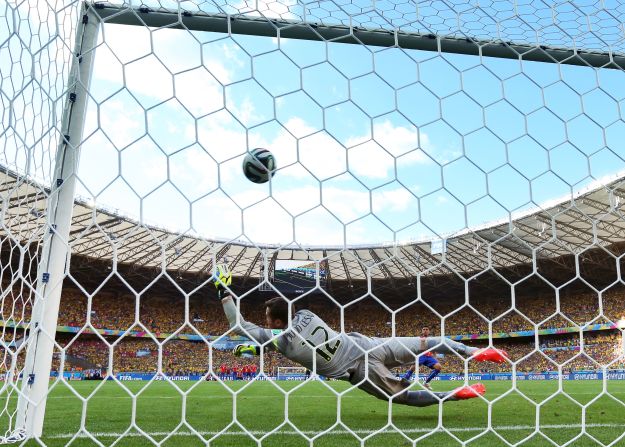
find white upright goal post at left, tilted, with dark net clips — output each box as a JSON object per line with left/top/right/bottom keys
{"left": 15, "top": 4, "right": 99, "bottom": 438}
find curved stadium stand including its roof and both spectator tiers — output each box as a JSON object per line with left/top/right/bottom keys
{"left": 0, "top": 167, "right": 625, "bottom": 382}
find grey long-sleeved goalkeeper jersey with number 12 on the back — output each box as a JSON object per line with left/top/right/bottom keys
{"left": 222, "top": 297, "right": 364, "bottom": 380}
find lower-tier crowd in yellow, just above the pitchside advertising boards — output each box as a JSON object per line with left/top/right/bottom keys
{"left": 42, "top": 330, "right": 625, "bottom": 378}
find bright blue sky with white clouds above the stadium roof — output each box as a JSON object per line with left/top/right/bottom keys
{"left": 0, "top": 2, "right": 625, "bottom": 245}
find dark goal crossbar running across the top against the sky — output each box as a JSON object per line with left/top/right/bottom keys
{"left": 93, "top": 3, "right": 625, "bottom": 70}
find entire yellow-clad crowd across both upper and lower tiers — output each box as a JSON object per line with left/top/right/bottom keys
{"left": 0, "top": 288, "right": 625, "bottom": 375}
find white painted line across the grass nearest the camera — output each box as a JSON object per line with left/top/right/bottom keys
{"left": 42, "top": 424, "right": 625, "bottom": 439}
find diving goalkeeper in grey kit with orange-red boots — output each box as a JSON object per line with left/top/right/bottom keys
{"left": 214, "top": 265, "right": 507, "bottom": 407}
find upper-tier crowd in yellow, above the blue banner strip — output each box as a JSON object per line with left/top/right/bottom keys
{"left": 0, "top": 287, "right": 625, "bottom": 337}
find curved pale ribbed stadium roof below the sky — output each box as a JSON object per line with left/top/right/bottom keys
{"left": 0, "top": 169, "right": 625, "bottom": 284}
